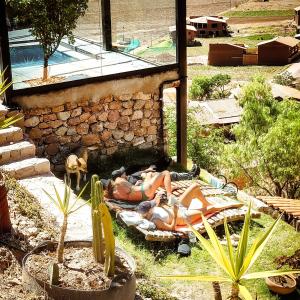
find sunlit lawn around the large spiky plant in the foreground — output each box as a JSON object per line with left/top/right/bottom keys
{"left": 115, "top": 214, "right": 300, "bottom": 300}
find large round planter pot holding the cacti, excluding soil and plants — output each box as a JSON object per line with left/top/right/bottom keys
{"left": 22, "top": 241, "right": 136, "bottom": 300}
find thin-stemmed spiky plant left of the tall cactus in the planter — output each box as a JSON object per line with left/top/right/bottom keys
{"left": 43, "top": 179, "right": 89, "bottom": 263}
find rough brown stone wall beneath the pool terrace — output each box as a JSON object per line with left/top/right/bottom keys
{"left": 23, "top": 92, "right": 163, "bottom": 171}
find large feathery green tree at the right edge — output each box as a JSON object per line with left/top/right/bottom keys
{"left": 226, "top": 77, "right": 300, "bottom": 198}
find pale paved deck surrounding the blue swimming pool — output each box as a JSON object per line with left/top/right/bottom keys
{"left": 9, "top": 30, "right": 156, "bottom": 89}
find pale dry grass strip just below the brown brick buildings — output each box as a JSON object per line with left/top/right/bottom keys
{"left": 188, "top": 65, "right": 288, "bottom": 81}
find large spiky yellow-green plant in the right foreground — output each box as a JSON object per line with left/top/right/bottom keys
{"left": 159, "top": 205, "right": 300, "bottom": 300}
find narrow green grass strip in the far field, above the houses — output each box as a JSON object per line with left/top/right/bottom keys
{"left": 224, "top": 9, "right": 294, "bottom": 17}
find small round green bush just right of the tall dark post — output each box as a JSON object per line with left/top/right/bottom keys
{"left": 189, "top": 74, "right": 231, "bottom": 100}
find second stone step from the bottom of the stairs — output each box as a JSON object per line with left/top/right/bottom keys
{"left": 0, "top": 141, "right": 35, "bottom": 165}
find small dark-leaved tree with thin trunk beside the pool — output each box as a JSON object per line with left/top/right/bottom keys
{"left": 10, "top": 0, "right": 88, "bottom": 80}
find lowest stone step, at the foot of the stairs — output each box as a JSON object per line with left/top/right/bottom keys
{"left": 0, "top": 157, "right": 50, "bottom": 179}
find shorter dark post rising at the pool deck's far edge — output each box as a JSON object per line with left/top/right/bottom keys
{"left": 101, "top": 0, "right": 112, "bottom": 51}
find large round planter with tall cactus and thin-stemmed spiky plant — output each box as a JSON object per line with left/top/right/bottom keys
{"left": 23, "top": 175, "right": 136, "bottom": 300}
